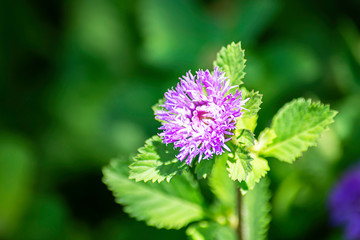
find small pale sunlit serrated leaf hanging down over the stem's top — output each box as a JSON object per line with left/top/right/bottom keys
{"left": 227, "top": 147, "right": 253, "bottom": 182}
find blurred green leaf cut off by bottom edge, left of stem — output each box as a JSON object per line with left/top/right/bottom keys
{"left": 186, "top": 221, "right": 236, "bottom": 240}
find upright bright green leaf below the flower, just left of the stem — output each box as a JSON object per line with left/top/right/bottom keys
{"left": 209, "top": 154, "right": 236, "bottom": 212}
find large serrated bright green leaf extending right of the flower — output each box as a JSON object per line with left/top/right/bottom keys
{"left": 260, "top": 98, "right": 337, "bottom": 163}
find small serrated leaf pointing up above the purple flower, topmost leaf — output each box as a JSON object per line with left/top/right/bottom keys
{"left": 214, "top": 42, "right": 246, "bottom": 86}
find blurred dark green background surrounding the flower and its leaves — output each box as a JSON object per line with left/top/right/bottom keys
{"left": 0, "top": 0, "right": 360, "bottom": 240}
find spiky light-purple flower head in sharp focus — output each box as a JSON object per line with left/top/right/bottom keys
{"left": 155, "top": 67, "right": 246, "bottom": 165}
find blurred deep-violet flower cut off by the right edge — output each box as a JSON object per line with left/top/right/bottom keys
{"left": 329, "top": 166, "right": 360, "bottom": 240}
